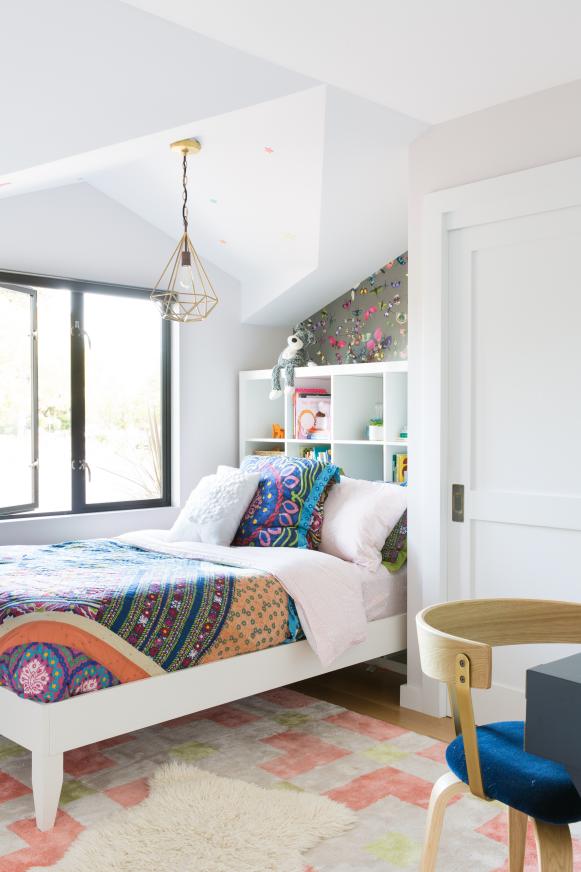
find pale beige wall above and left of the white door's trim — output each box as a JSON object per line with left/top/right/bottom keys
{"left": 402, "top": 81, "right": 581, "bottom": 708}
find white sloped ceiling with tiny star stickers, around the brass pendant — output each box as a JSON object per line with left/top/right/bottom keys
{"left": 0, "top": 0, "right": 426, "bottom": 324}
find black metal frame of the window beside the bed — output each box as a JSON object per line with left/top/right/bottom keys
{"left": 0, "top": 270, "right": 172, "bottom": 523}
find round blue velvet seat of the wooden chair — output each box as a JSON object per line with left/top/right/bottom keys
{"left": 446, "top": 721, "right": 581, "bottom": 824}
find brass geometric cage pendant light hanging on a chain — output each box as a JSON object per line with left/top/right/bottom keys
{"left": 151, "top": 139, "right": 218, "bottom": 324}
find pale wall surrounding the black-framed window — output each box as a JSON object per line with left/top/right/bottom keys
{"left": 0, "top": 184, "right": 288, "bottom": 544}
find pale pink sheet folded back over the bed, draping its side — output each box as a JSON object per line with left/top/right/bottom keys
{"left": 119, "top": 530, "right": 376, "bottom": 666}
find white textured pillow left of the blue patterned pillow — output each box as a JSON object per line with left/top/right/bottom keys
{"left": 168, "top": 467, "right": 260, "bottom": 545}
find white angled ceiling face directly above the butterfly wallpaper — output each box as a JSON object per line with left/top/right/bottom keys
{"left": 240, "top": 87, "right": 426, "bottom": 324}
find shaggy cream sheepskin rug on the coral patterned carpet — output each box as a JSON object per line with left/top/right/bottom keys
{"left": 37, "top": 763, "right": 355, "bottom": 872}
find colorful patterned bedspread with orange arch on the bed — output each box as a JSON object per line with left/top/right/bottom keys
{"left": 0, "top": 540, "right": 301, "bottom": 702}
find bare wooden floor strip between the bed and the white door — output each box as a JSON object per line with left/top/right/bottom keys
{"left": 293, "top": 664, "right": 454, "bottom": 742}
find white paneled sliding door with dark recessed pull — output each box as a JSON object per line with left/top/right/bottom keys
{"left": 443, "top": 204, "right": 581, "bottom": 722}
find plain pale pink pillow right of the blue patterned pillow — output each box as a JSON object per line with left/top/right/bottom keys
{"left": 319, "top": 476, "right": 407, "bottom": 572}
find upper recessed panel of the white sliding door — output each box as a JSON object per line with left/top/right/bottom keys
{"left": 471, "top": 225, "right": 581, "bottom": 495}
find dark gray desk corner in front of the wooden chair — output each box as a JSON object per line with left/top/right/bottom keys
{"left": 525, "top": 654, "right": 581, "bottom": 794}
